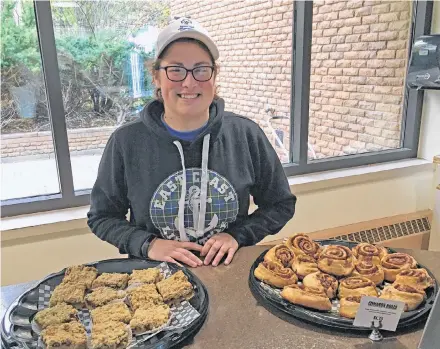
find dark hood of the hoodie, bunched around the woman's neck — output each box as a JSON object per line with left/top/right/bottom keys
{"left": 141, "top": 98, "right": 225, "bottom": 143}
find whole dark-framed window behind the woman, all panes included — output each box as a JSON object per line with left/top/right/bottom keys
{"left": 1, "top": 0, "right": 432, "bottom": 216}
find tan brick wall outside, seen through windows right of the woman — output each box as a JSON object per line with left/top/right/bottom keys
{"left": 171, "top": 0, "right": 411, "bottom": 158}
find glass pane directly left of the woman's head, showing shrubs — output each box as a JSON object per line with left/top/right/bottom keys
{"left": 51, "top": 0, "right": 169, "bottom": 190}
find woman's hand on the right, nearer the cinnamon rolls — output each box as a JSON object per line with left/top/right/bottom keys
{"left": 200, "top": 233, "right": 238, "bottom": 267}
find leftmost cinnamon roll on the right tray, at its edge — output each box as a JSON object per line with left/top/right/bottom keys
{"left": 254, "top": 261, "right": 298, "bottom": 288}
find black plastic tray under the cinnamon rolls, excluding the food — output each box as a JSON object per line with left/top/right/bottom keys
{"left": 249, "top": 240, "right": 438, "bottom": 331}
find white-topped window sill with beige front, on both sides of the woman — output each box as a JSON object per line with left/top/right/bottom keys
{"left": 1, "top": 159, "right": 434, "bottom": 241}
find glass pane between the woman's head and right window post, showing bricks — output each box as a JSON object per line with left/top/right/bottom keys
{"left": 170, "top": 0, "right": 293, "bottom": 162}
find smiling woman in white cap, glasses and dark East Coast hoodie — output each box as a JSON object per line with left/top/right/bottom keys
{"left": 88, "top": 18, "right": 296, "bottom": 267}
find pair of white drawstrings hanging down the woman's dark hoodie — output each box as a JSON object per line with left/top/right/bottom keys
{"left": 173, "top": 134, "right": 211, "bottom": 241}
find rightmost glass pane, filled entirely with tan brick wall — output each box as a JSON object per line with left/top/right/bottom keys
{"left": 309, "top": 0, "right": 412, "bottom": 160}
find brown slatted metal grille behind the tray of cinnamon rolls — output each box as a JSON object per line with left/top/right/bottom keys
{"left": 334, "top": 217, "right": 431, "bottom": 244}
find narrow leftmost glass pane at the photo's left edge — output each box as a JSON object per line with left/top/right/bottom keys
{"left": 1, "top": 1, "right": 60, "bottom": 200}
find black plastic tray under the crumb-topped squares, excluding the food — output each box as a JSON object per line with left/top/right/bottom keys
{"left": 1, "top": 258, "right": 209, "bottom": 349}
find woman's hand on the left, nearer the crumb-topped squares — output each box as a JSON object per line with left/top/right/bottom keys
{"left": 148, "top": 239, "right": 203, "bottom": 268}
